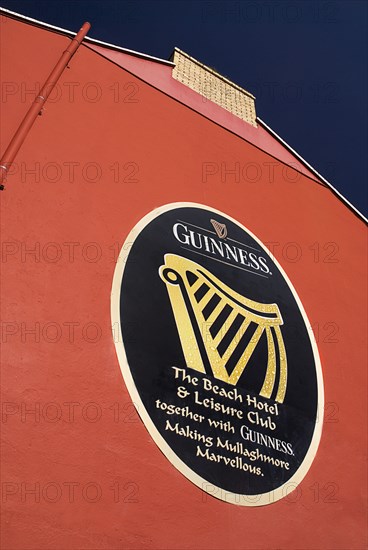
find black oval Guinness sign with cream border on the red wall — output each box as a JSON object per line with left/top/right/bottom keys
{"left": 112, "top": 203, "right": 323, "bottom": 506}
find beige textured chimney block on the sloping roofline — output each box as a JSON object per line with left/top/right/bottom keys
{"left": 171, "top": 48, "right": 257, "bottom": 126}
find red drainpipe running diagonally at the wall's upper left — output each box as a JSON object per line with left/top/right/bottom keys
{"left": 0, "top": 22, "right": 91, "bottom": 191}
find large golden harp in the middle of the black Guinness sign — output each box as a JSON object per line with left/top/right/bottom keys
{"left": 159, "top": 254, "right": 287, "bottom": 403}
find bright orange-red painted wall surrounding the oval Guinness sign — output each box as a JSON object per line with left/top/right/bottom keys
{"left": 1, "top": 14, "right": 366, "bottom": 550}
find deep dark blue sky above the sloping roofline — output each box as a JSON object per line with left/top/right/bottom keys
{"left": 0, "top": 0, "right": 368, "bottom": 218}
